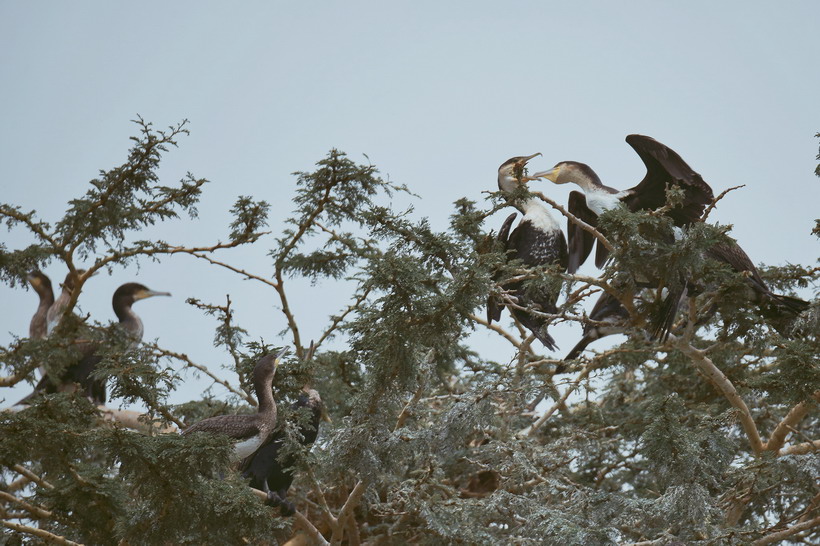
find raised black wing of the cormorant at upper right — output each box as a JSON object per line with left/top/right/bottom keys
{"left": 622, "top": 135, "right": 714, "bottom": 226}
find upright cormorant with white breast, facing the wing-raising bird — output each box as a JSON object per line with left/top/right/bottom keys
{"left": 487, "top": 154, "right": 567, "bottom": 350}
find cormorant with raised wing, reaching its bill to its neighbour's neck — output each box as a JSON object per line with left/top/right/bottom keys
{"left": 532, "top": 135, "right": 714, "bottom": 273}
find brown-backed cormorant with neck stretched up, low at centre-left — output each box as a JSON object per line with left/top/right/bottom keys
{"left": 182, "top": 346, "right": 290, "bottom": 461}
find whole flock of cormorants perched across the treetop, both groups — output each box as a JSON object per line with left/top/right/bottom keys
{"left": 9, "top": 135, "right": 808, "bottom": 515}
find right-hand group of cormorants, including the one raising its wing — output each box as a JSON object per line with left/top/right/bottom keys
{"left": 487, "top": 135, "right": 809, "bottom": 360}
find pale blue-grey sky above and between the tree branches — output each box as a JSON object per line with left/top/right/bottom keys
{"left": 0, "top": 0, "right": 820, "bottom": 406}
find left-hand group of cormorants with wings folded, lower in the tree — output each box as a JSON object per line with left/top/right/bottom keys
{"left": 15, "top": 270, "right": 326, "bottom": 516}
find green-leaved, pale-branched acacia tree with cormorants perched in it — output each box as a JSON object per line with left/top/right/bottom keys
{"left": 0, "top": 120, "right": 820, "bottom": 545}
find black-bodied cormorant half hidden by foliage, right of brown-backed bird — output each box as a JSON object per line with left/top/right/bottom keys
{"left": 241, "top": 388, "right": 326, "bottom": 516}
